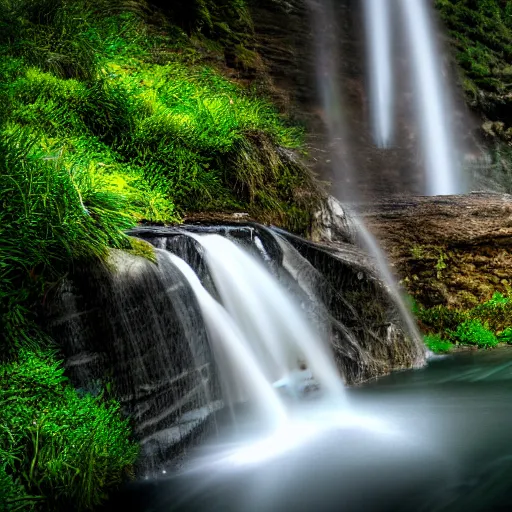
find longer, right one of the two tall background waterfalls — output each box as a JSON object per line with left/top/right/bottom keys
{"left": 400, "top": 0, "right": 462, "bottom": 195}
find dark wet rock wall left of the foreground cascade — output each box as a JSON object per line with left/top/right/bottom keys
{"left": 48, "top": 251, "right": 218, "bottom": 471}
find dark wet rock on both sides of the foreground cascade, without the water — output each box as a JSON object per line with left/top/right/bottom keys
{"left": 48, "top": 222, "right": 425, "bottom": 471}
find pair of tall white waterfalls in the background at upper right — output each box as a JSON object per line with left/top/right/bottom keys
{"left": 365, "top": 0, "right": 464, "bottom": 195}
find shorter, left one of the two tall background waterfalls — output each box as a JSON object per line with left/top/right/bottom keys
{"left": 364, "top": 0, "right": 394, "bottom": 148}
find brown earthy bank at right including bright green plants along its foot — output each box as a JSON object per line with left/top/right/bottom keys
{"left": 365, "top": 193, "right": 512, "bottom": 351}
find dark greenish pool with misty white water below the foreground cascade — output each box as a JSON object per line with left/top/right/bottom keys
{"left": 112, "top": 348, "right": 512, "bottom": 512}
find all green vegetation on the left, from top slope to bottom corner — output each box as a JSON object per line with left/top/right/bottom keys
{"left": 0, "top": 0, "right": 317, "bottom": 510}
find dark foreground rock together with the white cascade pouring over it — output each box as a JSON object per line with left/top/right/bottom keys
{"left": 48, "top": 224, "right": 424, "bottom": 475}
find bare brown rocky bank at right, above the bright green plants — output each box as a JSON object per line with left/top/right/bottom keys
{"left": 363, "top": 193, "right": 512, "bottom": 308}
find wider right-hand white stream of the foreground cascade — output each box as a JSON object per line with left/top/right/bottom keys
{"left": 191, "top": 235, "right": 344, "bottom": 399}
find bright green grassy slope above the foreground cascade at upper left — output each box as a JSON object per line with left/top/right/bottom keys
{"left": 0, "top": 0, "right": 317, "bottom": 353}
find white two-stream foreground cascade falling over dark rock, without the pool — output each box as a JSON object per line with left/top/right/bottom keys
{"left": 166, "top": 234, "right": 346, "bottom": 444}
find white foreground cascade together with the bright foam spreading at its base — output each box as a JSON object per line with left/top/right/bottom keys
{"left": 164, "top": 234, "right": 389, "bottom": 471}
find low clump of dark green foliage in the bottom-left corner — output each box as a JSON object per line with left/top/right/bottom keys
{"left": 0, "top": 350, "right": 138, "bottom": 510}
